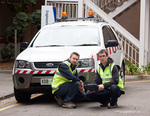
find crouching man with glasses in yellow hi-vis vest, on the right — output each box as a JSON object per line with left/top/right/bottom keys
{"left": 87, "top": 49, "right": 124, "bottom": 109}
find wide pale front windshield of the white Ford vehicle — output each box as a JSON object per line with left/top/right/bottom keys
{"left": 31, "top": 25, "right": 100, "bottom": 47}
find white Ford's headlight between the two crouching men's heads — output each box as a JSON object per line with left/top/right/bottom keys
{"left": 78, "top": 58, "right": 94, "bottom": 67}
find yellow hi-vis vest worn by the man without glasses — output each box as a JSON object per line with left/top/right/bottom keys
{"left": 52, "top": 61, "right": 77, "bottom": 94}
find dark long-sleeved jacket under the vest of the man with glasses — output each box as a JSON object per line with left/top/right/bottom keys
{"left": 95, "top": 58, "right": 119, "bottom": 88}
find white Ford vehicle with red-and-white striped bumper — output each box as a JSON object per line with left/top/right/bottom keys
{"left": 13, "top": 15, "right": 125, "bottom": 102}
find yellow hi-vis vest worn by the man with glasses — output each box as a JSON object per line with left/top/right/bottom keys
{"left": 97, "top": 63, "right": 124, "bottom": 91}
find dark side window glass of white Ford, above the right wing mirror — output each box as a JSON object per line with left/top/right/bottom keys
{"left": 102, "top": 26, "right": 117, "bottom": 43}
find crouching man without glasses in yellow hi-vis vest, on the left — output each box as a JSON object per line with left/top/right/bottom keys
{"left": 52, "top": 52, "right": 86, "bottom": 108}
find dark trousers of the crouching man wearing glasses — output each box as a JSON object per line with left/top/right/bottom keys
{"left": 87, "top": 85, "right": 121, "bottom": 106}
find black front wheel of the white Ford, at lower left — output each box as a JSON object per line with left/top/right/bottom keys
{"left": 14, "top": 88, "right": 31, "bottom": 102}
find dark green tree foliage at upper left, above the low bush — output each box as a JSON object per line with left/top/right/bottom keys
{"left": 4, "top": 0, "right": 36, "bottom": 43}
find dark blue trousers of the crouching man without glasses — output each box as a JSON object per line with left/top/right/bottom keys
{"left": 55, "top": 81, "right": 86, "bottom": 102}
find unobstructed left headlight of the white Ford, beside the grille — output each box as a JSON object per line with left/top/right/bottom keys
{"left": 15, "top": 60, "right": 29, "bottom": 68}
